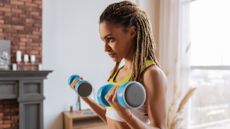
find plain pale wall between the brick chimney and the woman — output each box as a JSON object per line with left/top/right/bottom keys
{"left": 42, "top": 0, "right": 122, "bottom": 129}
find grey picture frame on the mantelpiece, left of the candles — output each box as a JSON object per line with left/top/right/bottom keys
{"left": 0, "top": 40, "right": 11, "bottom": 70}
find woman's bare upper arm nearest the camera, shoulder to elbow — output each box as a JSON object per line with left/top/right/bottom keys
{"left": 143, "top": 66, "right": 167, "bottom": 129}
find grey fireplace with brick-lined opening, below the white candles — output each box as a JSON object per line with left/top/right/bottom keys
{"left": 0, "top": 71, "right": 51, "bottom": 129}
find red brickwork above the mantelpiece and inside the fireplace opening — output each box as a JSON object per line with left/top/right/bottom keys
{"left": 0, "top": 0, "right": 42, "bottom": 129}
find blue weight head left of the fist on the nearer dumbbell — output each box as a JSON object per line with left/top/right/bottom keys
{"left": 97, "top": 84, "right": 113, "bottom": 107}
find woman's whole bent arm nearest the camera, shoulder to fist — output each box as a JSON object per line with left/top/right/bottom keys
{"left": 106, "top": 66, "right": 167, "bottom": 129}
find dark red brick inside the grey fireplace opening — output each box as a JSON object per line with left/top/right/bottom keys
{"left": 0, "top": 99, "right": 19, "bottom": 129}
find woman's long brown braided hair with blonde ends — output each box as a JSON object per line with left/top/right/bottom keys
{"left": 99, "top": 1, "right": 159, "bottom": 81}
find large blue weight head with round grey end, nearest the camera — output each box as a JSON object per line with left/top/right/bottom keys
{"left": 117, "top": 81, "right": 146, "bottom": 108}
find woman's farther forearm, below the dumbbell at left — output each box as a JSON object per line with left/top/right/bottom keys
{"left": 82, "top": 97, "right": 107, "bottom": 123}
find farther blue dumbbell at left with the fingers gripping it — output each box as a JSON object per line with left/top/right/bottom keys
{"left": 69, "top": 75, "right": 93, "bottom": 97}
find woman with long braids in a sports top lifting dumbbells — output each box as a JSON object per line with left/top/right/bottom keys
{"left": 83, "top": 1, "right": 167, "bottom": 129}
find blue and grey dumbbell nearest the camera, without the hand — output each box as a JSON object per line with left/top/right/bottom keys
{"left": 97, "top": 81, "right": 146, "bottom": 108}
